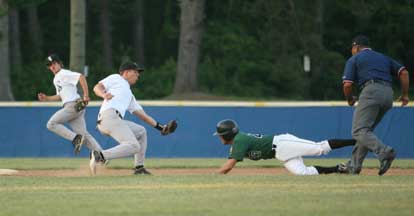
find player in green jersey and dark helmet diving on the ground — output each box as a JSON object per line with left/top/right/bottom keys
{"left": 214, "top": 119, "right": 355, "bottom": 175}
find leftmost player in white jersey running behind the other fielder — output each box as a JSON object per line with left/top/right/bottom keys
{"left": 37, "top": 54, "right": 102, "bottom": 154}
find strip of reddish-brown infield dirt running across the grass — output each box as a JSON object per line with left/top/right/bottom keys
{"left": 2, "top": 168, "right": 414, "bottom": 177}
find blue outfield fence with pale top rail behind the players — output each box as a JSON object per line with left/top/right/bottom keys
{"left": 0, "top": 101, "right": 414, "bottom": 158}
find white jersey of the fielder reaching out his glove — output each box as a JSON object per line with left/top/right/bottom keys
{"left": 99, "top": 74, "right": 143, "bottom": 117}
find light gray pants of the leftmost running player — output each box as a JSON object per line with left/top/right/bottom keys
{"left": 46, "top": 102, "right": 102, "bottom": 151}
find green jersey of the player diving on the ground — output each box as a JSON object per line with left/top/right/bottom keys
{"left": 229, "top": 132, "right": 275, "bottom": 161}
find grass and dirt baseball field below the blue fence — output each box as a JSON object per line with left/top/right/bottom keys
{"left": 0, "top": 158, "right": 414, "bottom": 216}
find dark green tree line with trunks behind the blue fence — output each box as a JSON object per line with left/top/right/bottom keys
{"left": 0, "top": 0, "right": 414, "bottom": 100}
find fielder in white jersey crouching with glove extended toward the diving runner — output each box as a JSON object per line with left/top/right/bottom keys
{"left": 89, "top": 62, "right": 177, "bottom": 175}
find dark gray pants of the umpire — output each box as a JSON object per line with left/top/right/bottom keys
{"left": 348, "top": 83, "right": 393, "bottom": 174}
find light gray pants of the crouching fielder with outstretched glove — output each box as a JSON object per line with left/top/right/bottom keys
{"left": 98, "top": 109, "right": 147, "bottom": 166}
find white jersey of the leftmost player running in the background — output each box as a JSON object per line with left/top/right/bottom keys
{"left": 53, "top": 68, "right": 81, "bottom": 104}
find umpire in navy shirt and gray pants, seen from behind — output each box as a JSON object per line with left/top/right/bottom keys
{"left": 342, "top": 35, "right": 409, "bottom": 175}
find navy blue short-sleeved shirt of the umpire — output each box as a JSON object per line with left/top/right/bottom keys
{"left": 342, "top": 48, "right": 405, "bottom": 87}
